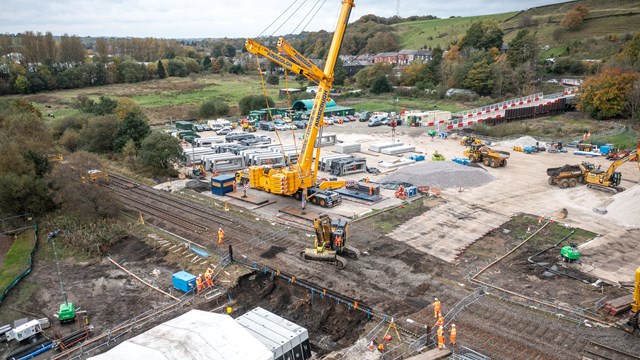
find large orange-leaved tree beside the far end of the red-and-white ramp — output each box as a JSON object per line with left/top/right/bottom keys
{"left": 578, "top": 68, "right": 640, "bottom": 119}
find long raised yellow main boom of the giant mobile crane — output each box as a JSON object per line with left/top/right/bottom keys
{"left": 298, "top": 0, "right": 355, "bottom": 179}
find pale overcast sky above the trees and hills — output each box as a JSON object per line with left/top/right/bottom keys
{"left": 0, "top": 0, "right": 562, "bottom": 38}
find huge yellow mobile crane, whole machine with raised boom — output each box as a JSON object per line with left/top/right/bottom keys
{"left": 236, "top": 0, "right": 355, "bottom": 207}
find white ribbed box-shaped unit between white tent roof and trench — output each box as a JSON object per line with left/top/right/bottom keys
{"left": 236, "top": 307, "right": 311, "bottom": 360}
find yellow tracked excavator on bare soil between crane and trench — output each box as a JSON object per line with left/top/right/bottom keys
{"left": 301, "top": 215, "right": 360, "bottom": 270}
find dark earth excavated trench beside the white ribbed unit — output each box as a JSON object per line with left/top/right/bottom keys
{"left": 229, "top": 272, "right": 368, "bottom": 355}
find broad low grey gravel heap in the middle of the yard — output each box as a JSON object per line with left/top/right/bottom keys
{"left": 381, "top": 161, "right": 495, "bottom": 189}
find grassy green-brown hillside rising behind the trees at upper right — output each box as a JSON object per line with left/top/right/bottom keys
{"left": 395, "top": 0, "right": 640, "bottom": 59}
